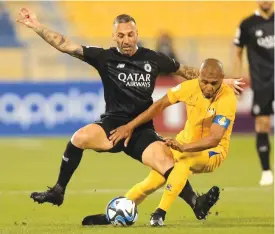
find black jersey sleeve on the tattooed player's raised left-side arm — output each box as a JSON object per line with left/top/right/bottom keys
{"left": 82, "top": 46, "right": 104, "bottom": 69}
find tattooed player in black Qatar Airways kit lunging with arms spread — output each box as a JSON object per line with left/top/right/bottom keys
{"left": 17, "top": 8, "right": 243, "bottom": 224}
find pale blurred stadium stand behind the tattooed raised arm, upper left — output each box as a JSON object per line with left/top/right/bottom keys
{"left": 0, "top": 2, "right": 97, "bottom": 81}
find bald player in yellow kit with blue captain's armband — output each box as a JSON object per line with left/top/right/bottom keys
{"left": 111, "top": 59, "right": 237, "bottom": 226}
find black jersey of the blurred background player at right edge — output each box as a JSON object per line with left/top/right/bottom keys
{"left": 234, "top": 11, "right": 274, "bottom": 90}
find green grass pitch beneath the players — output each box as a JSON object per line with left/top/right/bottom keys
{"left": 0, "top": 135, "right": 274, "bottom": 234}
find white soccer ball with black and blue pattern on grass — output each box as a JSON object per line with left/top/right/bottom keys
{"left": 106, "top": 197, "right": 138, "bottom": 226}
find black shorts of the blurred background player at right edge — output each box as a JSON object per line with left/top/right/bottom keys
{"left": 251, "top": 87, "right": 274, "bottom": 116}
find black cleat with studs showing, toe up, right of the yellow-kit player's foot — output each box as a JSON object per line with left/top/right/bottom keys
{"left": 193, "top": 186, "right": 220, "bottom": 220}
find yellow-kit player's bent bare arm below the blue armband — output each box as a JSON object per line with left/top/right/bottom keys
{"left": 166, "top": 123, "right": 226, "bottom": 152}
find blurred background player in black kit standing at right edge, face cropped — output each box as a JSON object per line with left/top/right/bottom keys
{"left": 234, "top": 1, "right": 274, "bottom": 185}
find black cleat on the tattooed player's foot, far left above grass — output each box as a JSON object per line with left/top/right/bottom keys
{"left": 30, "top": 185, "right": 64, "bottom": 206}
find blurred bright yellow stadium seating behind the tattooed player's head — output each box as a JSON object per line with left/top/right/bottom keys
{"left": 58, "top": 1, "right": 256, "bottom": 39}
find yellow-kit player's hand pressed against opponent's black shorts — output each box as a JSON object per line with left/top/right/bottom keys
{"left": 109, "top": 125, "right": 133, "bottom": 147}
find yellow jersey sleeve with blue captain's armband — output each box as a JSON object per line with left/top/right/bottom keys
{"left": 213, "top": 93, "right": 237, "bottom": 129}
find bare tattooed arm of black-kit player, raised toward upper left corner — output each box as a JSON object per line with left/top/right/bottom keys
{"left": 16, "top": 8, "right": 83, "bottom": 60}
